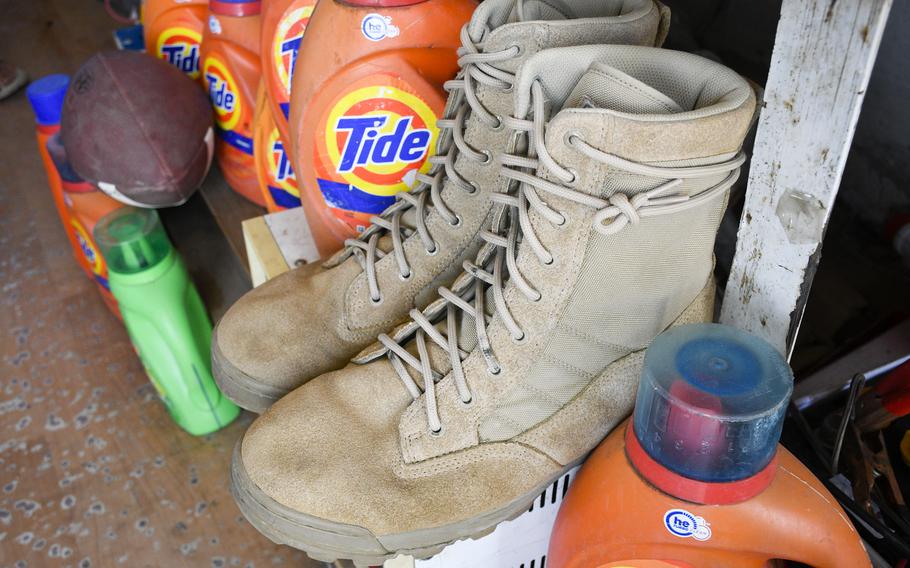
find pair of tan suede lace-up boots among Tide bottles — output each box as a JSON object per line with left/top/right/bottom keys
{"left": 213, "top": 0, "right": 756, "bottom": 566}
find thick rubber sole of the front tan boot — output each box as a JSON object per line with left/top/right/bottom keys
{"left": 231, "top": 438, "right": 584, "bottom": 568}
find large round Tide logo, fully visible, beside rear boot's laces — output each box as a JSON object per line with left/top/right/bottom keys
{"left": 325, "top": 85, "right": 439, "bottom": 196}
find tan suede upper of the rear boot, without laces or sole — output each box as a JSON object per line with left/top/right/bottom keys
{"left": 216, "top": 0, "right": 668, "bottom": 405}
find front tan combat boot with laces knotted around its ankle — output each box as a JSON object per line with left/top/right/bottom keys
{"left": 232, "top": 46, "right": 755, "bottom": 565}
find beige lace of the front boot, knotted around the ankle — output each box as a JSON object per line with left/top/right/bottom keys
{"left": 379, "top": 77, "right": 745, "bottom": 435}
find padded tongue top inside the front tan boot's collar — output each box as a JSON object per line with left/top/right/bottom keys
{"left": 563, "top": 63, "right": 683, "bottom": 114}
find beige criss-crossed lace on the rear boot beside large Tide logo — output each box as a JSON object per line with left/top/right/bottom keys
{"left": 325, "top": 25, "right": 521, "bottom": 304}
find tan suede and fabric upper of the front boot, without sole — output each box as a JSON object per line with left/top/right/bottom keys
{"left": 241, "top": 46, "right": 755, "bottom": 536}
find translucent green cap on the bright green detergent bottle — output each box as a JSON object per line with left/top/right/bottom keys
{"left": 93, "top": 207, "right": 171, "bottom": 274}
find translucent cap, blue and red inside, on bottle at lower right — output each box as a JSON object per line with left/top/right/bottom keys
{"left": 633, "top": 324, "right": 793, "bottom": 482}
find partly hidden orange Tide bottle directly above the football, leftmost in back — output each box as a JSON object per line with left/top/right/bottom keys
{"left": 142, "top": 0, "right": 209, "bottom": 79}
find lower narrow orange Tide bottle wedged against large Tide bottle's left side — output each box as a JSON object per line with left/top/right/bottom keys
{"left": 253, "top": 81, "right": 300, "bottom": 213}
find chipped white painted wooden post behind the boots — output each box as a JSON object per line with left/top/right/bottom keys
{"left": 721, "top": 0, "right": 891, "bottom": 357}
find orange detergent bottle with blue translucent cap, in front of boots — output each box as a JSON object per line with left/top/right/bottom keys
{"left": 547, "top": 324, "right": 870, "bottom": 568}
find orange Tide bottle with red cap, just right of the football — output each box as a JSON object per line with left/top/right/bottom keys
{"left": 200, "top": 0, "right": 265, "bottom": 206}
